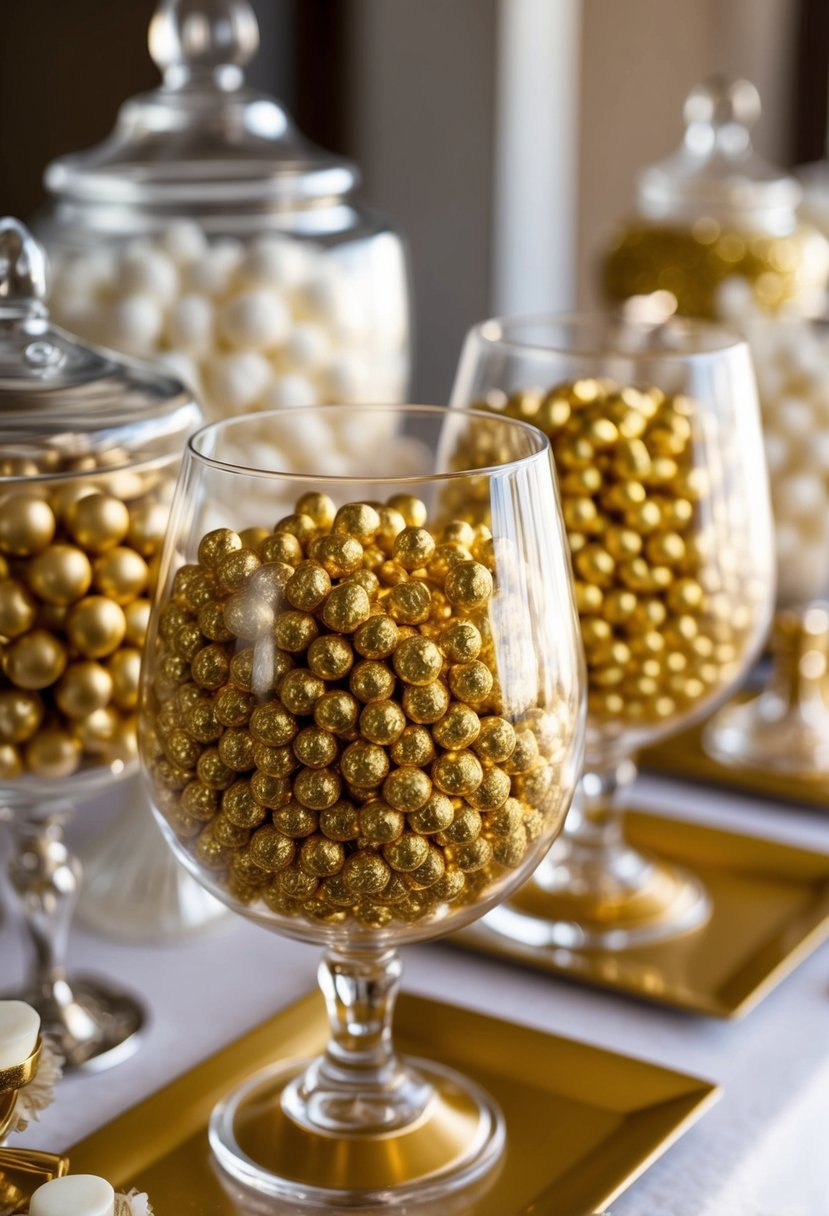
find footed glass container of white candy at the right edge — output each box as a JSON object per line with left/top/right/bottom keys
{"left": 705, "top": 304, "right": 829, "bottom": 777}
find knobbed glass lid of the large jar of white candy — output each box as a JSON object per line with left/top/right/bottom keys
{"left": 44, "top": 0, "right": 359, "bottom": 212}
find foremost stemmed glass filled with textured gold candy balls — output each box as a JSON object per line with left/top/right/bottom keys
{"left": 140, "top": 406, "right": 583, "bottom": 1206}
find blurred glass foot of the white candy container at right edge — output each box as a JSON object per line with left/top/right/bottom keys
{"left": 703, "top": 692, "right": 829, "bottom": 778}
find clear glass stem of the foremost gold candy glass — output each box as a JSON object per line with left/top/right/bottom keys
{"left": 282, "top": 947, "right": 433, "bottom": 1135}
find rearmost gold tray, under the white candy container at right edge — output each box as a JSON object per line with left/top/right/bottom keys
{"left": 639, "top": 710, "right": 829, "bottom": 811}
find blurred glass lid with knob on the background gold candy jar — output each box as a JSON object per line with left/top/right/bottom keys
{"left": 637, "top": 77, "right": 801, "bottom": 220}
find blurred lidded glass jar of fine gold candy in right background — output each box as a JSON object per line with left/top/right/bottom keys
{"left": 602, "top": 78, "right": 829, "bottom": 319}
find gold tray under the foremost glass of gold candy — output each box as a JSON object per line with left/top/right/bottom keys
{"left": 69, "top": 993, "right": 720, "bottom": 1216}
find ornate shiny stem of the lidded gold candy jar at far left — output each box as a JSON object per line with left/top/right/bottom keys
{"left": 9, "top": 803, "right": 80, "bottom": 1001}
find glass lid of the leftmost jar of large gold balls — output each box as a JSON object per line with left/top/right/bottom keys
{"left": 0, "top": 216, "right": 201, "bottom": 466}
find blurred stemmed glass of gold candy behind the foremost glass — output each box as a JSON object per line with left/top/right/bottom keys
{"left": 452, "top": 316, "right": 773, "bottom": 950}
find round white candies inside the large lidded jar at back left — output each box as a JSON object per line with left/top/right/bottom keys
{"left": 45, "top": 220, "right": 408, "bottom": 430}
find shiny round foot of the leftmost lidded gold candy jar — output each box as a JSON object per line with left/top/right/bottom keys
{"left": 15, "top": 975, "right": 147, "bottom": 1073}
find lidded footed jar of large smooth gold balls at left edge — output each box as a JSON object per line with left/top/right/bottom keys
{"left": 0, "top": 219, "right": 201, "bottom": 1068}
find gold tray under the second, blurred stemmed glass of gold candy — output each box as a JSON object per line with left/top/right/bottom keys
{"left": 451, "top": 811, "right": 829, "bottom": 1018}
